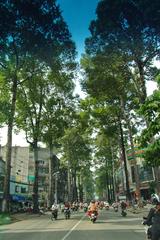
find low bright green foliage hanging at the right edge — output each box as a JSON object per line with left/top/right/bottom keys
{"left": 139, "top": 77, "right": 160, "bottom": 166}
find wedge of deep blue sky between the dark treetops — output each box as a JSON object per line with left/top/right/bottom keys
{"left": 57, "top": 0, "right": 99, "bottom": 57}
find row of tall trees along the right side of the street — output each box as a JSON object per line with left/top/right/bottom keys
{"left": 81, "top": 0, "right": 160, "bottom": 202}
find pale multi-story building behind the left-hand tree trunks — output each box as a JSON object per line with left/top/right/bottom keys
{"left": 0, "top": 146, "right": 59, "bottom": 208}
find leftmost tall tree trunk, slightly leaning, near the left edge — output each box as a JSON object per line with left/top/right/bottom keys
{"left": 2, "top": 76, "right": 17, "bottom": 212}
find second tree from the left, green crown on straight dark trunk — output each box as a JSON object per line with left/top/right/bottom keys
{"left": 16, "top": 61, "right": 48, "bottom": 212}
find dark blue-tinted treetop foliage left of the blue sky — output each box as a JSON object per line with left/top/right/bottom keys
{"left": 0, "top": 0, "right": 75, "bottom": 65}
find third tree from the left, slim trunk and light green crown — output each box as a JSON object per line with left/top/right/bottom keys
{"left": 42, "top": 85, "right": 76, "bottom": 205}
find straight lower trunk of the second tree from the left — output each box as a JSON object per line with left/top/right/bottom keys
{"left": 33, "top": 141, "right": 39, "bottom": 213}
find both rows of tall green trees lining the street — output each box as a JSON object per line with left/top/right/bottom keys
{"left": 0, "top": 0, "right": 160, "bottom": 212}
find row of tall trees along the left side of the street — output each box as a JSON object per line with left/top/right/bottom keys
{"left": 0, "top": 0, "right": 94, "bottom": 212}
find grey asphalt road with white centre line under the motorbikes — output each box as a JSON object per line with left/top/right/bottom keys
{"left": 0, "top": 209, "right": 145, "bottom": 240}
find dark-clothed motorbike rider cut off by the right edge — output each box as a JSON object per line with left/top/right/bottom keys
{"left": 143, "top": 199, "right": 160, "bottom": 240}
